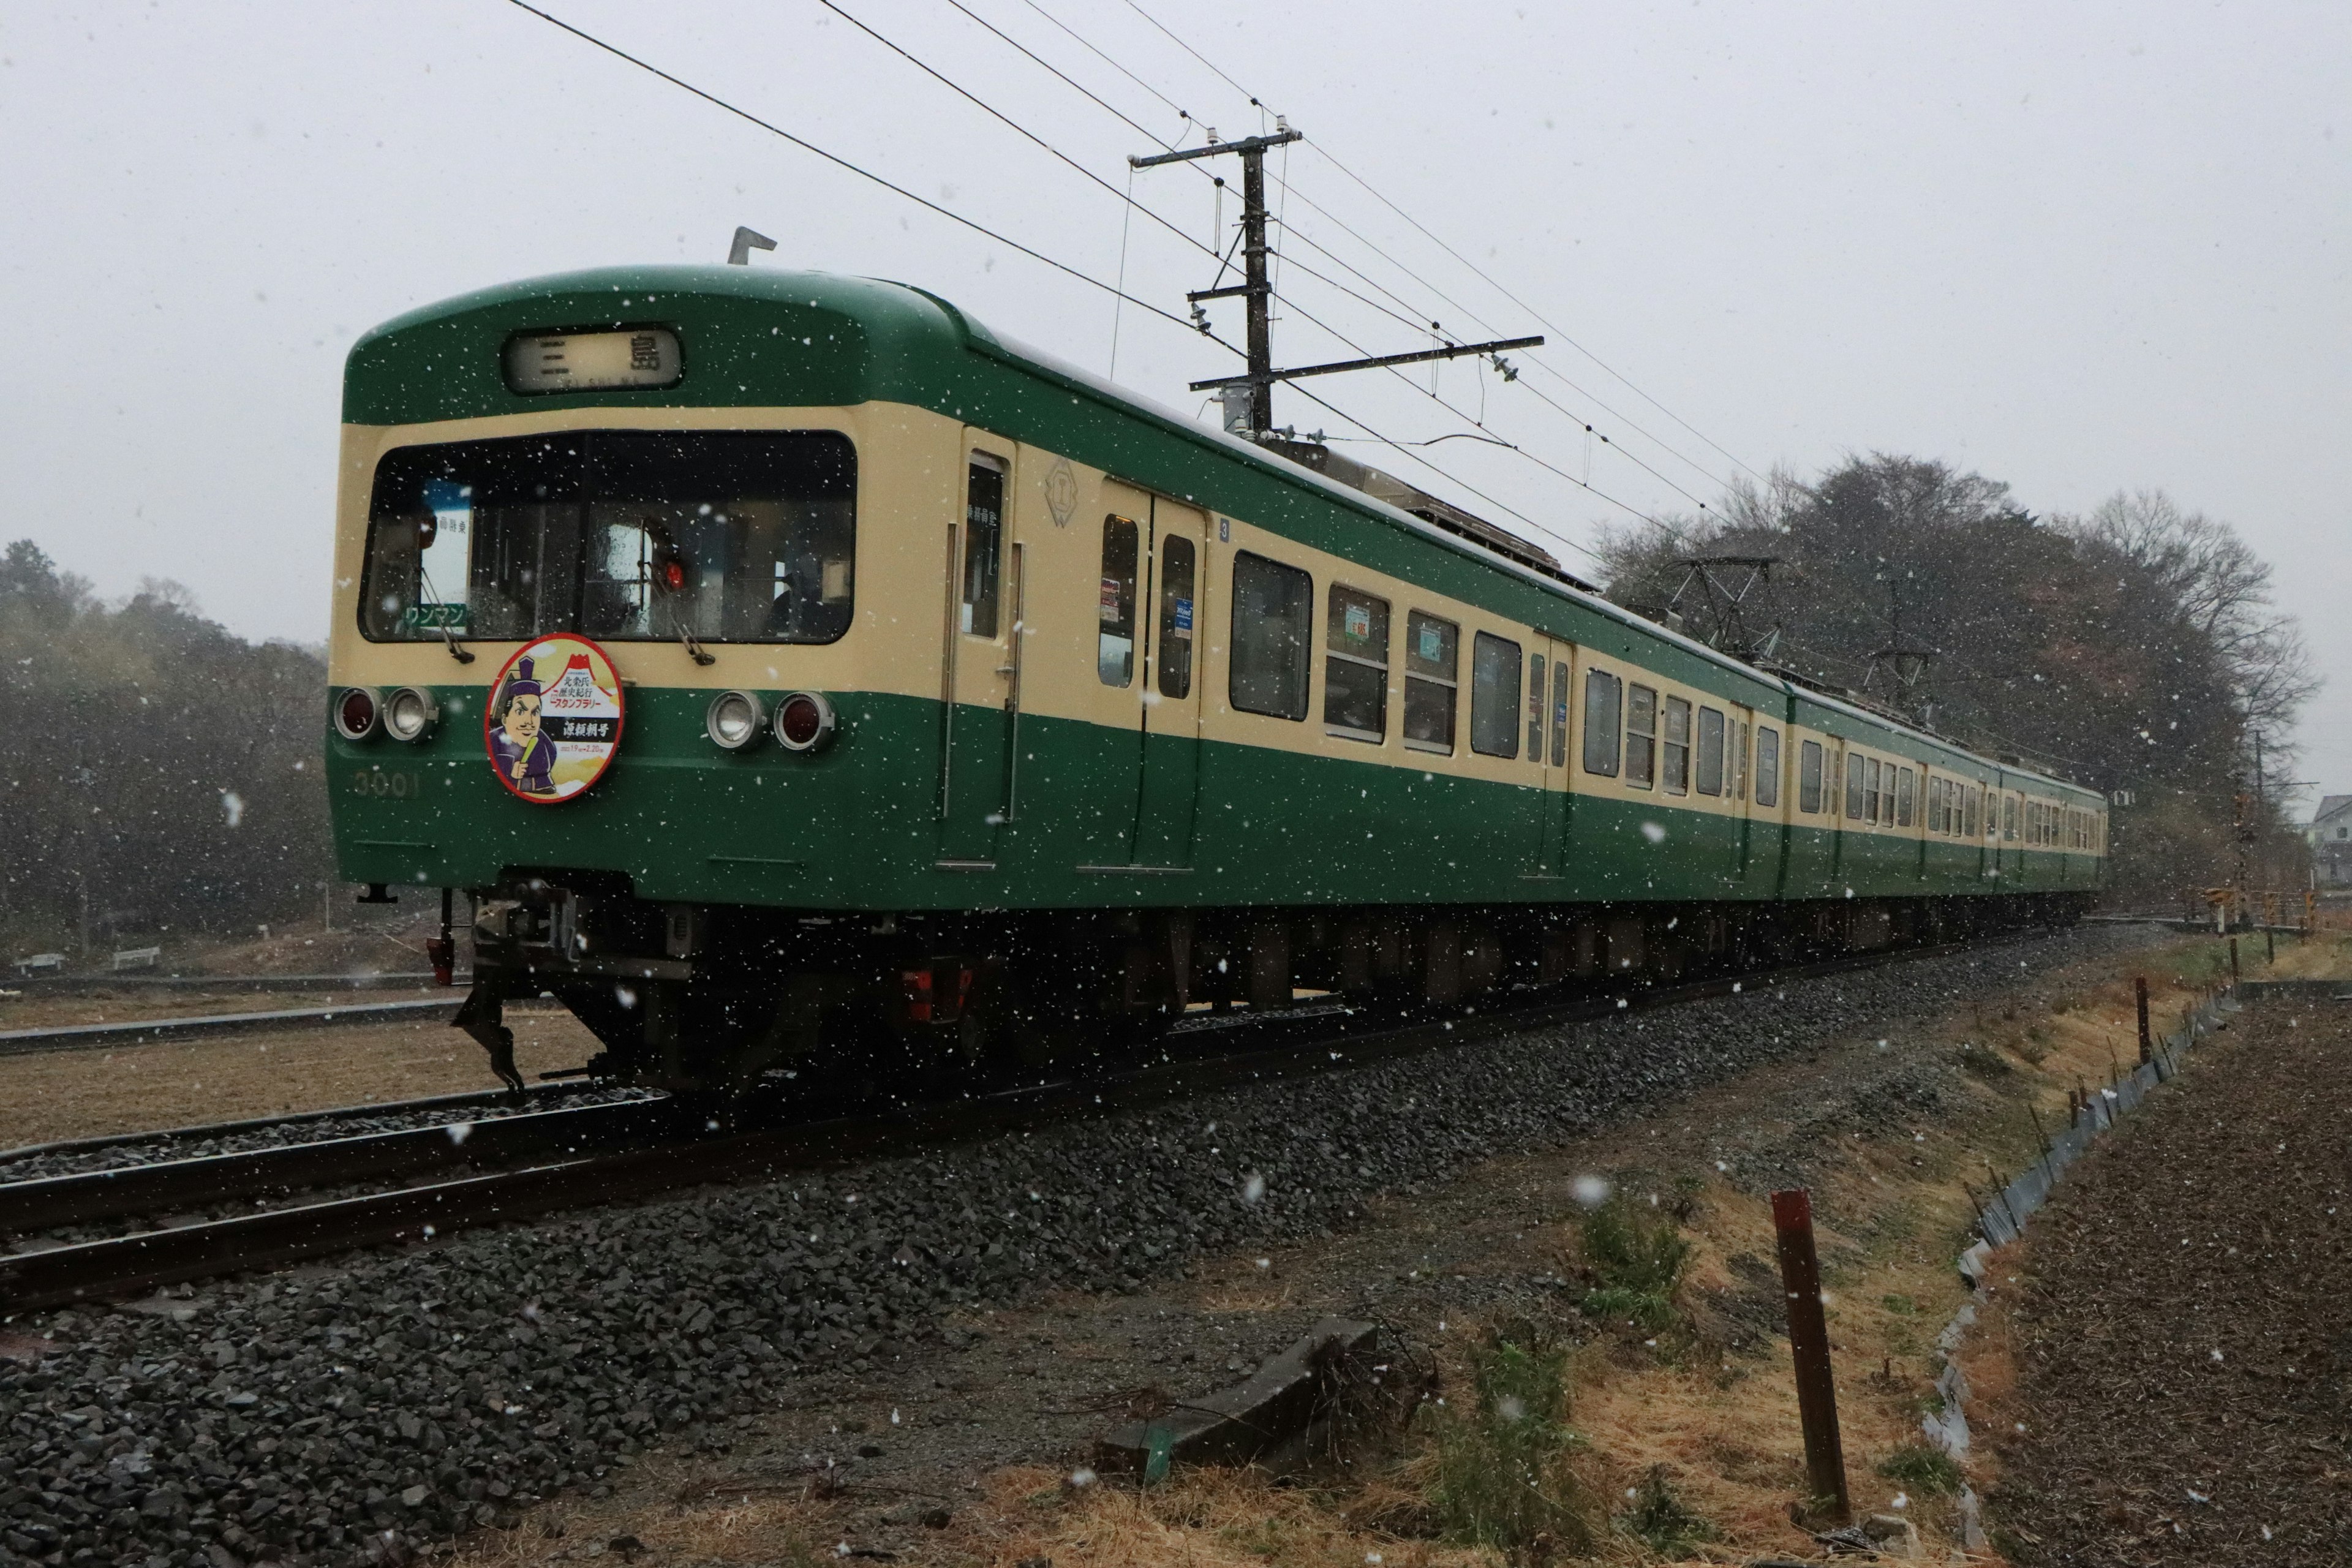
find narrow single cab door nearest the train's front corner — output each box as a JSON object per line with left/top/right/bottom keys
{"left": 938, "top": 430, "right": 1021, "bottom": 870}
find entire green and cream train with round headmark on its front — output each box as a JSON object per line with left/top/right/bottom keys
{"left": 327, "top": 268, "right": 2108, "bottom": 1091}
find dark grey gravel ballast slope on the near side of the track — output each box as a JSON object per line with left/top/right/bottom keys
{"left": 0, "top": 929, "right": 2145, "bottom": 1568}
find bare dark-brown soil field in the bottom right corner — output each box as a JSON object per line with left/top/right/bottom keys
{"left": 1969, "top": 987, "right": 2352, "bottom": 1568}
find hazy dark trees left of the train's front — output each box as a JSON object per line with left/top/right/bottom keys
{"left": 0, "top": 541, "right": 334, "bottom": 957}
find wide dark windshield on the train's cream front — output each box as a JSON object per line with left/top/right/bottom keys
{"left": 360, "top": 430, "right": 856, "bottom": 642}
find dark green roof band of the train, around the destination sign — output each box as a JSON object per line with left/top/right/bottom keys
{"left": 344, "top": 266, "right": 2095, "bottom": 799}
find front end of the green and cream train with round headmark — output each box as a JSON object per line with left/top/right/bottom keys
{"left": 327, "top": 268, "right": 1005, "bottom": 1091}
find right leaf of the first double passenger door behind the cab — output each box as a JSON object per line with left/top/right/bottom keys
{"left": 1134, "top": 496, "right": 1209, "bottom": 870}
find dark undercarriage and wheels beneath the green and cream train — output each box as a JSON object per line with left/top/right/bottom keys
{"left": 456, "top": 872, "right": 2091, "bottom": 1100}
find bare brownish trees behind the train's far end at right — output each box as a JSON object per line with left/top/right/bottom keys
{"left": 1602, "top": 454, "right": 2319, "bottom": 907}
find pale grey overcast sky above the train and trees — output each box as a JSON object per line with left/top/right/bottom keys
{"left": 0, "top": 0, "right": 2352, "bottom": 790}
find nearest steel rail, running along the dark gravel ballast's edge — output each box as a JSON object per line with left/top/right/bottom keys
{"left": 0, "top": 926, "right": 2079, "bottom": 1314}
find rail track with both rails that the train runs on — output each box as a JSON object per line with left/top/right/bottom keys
{"left": 0, "top": 929, "right": 2079, "bottom": 1314}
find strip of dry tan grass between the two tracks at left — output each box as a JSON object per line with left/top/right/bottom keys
{"left": 0, "top": 999, "right": 595, "bottom": 1147}
